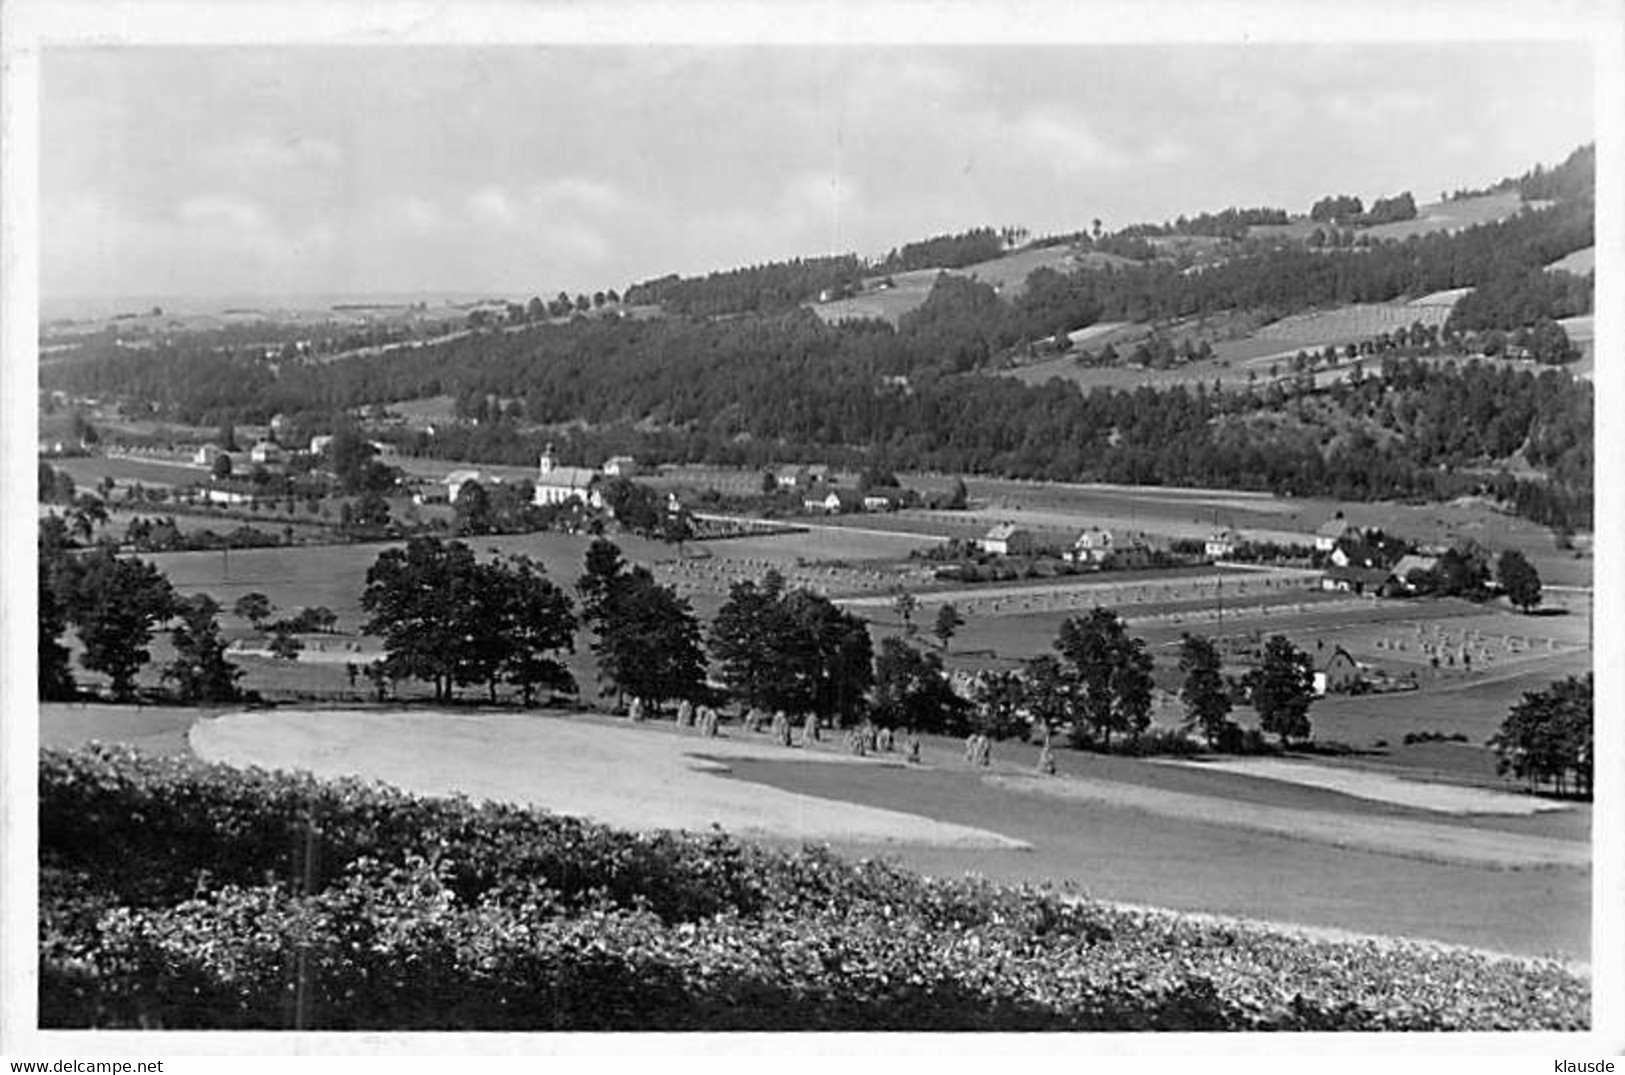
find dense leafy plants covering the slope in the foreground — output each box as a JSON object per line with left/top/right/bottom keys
{"left": 41, "top": 747, "right": 1589, "bottom": 1030}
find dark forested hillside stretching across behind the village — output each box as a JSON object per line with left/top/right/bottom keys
{"left": 42, "top": 149, "right": 1593, "bottom": 526}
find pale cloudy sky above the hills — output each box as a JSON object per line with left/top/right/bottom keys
{"left": 41, "top": 42, "right": 1594, "bottom": 299}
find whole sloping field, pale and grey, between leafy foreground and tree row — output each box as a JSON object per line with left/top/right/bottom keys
{"left": 120, "top": 711, "right": 1588, "bottom": 958}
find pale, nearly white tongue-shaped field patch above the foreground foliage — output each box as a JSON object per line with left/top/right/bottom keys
{"left": 190, "top": 710, "right": 1022, "bottom": 849}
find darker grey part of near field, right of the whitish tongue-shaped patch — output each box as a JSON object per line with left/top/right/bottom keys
{"left": 733, "top": 744, "right": 1591, "bottom": 960}
